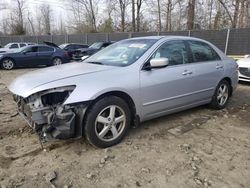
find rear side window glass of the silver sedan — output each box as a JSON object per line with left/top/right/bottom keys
{"left": 188, "top": 41, "right": 221, "bottom": 62}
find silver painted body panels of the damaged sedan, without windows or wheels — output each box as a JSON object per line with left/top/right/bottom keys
{"left": 9, "top": 36, "right": 238, "bottom": 121}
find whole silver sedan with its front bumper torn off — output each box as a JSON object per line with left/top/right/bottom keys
{"left": 9, "top": 36, "right": 238, "bottom": 148}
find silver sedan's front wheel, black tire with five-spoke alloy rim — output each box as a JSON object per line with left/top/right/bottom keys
{"left": 83, "top": 96, "right": 131, "bottom": 148}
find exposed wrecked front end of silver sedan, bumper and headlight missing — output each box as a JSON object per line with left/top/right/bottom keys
{"left": 14, "top": 86, "right": 87, "bottom": 141}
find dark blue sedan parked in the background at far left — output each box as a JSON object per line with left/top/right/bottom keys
{"left": 0, "top": 45, "right": 70, "bottom": 70}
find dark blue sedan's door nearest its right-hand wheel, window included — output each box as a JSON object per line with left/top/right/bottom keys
{"left": 37, "top": 46, "right": 55, "bottom": 65}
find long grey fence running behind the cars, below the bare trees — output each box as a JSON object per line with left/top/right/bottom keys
{"left": 0, "top": 28, "right": 250, "bottom": 55}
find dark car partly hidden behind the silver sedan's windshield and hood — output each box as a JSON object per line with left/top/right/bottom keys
{"left": 73, "top": 41, "right": 114, "bottom": 60}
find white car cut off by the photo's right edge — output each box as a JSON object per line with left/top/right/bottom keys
{"left": 237, "top": 55, "right": 250, "bottom": 82}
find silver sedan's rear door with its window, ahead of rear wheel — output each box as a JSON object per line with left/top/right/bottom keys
{"left": 187, "top": 40, "right": 224, "bottom": 100}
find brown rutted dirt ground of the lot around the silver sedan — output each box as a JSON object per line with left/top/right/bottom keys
{"left": 0, "top": 69, "right": 250, "bottom": 188}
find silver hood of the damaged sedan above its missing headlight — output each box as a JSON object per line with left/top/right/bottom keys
{"left": 9, "top": 63, "right": 115, "bottom": 97}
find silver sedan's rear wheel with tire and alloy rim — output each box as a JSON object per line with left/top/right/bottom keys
{"left": 209, "top": 80, "right": 230, "bottom": 110}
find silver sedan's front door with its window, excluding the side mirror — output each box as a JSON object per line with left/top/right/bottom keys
{"left": 140, "top": 40, "right": 195, "bottom": 119}
